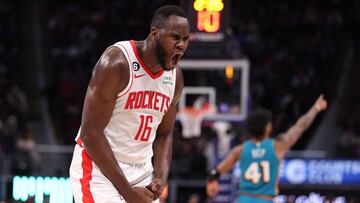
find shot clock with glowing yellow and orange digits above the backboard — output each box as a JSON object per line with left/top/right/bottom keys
{"left": 182, "top": 0, "right": 230, "bottom": 59}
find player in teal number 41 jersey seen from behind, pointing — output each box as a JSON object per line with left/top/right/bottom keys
{"left": 206, "top": 95, "right": 327, "bottom": 203}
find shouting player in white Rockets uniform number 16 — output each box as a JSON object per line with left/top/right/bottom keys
{"left": 70, "top": 6, "right": 190, "bottom": 203}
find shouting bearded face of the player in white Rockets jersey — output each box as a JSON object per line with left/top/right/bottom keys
{"left": 155, "top": 16, "right": 190, "bottom": 70}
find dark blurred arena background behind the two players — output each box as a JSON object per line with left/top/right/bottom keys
{"left": 0, "top": 0, "right": 360, "bottom": 203}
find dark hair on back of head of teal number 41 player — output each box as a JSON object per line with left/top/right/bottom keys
{"left": 245, "top": 108, "right": 272, "bottom": 138}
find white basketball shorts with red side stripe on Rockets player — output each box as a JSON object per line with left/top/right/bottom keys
{"left": 70, "top": 144, "right": 159, "bottom": 203}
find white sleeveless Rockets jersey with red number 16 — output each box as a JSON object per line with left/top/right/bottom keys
{"left": 77, "top": 40, "right": 176, "bottom": 164}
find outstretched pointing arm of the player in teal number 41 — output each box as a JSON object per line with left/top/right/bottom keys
{"left": 275, "top": 95, "right": 327, "bottom": 157}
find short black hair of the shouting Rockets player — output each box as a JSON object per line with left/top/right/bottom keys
{"left": 151, "top": 5, "right": 187, "bottom": 28}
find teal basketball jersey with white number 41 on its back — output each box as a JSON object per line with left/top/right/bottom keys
{"left": 239, "top": 139, "right": 280, "bottom": 196}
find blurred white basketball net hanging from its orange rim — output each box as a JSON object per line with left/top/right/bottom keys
{"left": 178, "top": 100, "right": 216, "bottom": 138}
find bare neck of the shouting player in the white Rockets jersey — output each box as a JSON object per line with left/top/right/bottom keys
{"left": 135, "top": 38, "right": 162, "bottom": 74}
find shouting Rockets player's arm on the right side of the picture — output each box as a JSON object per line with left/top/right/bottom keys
{"left": 149, "top": 67, "right": 184, "bottom": 199}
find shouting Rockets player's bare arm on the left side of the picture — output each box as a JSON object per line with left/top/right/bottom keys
{"left": 80, "top": 47, "right": 152, "bottom": 202}
